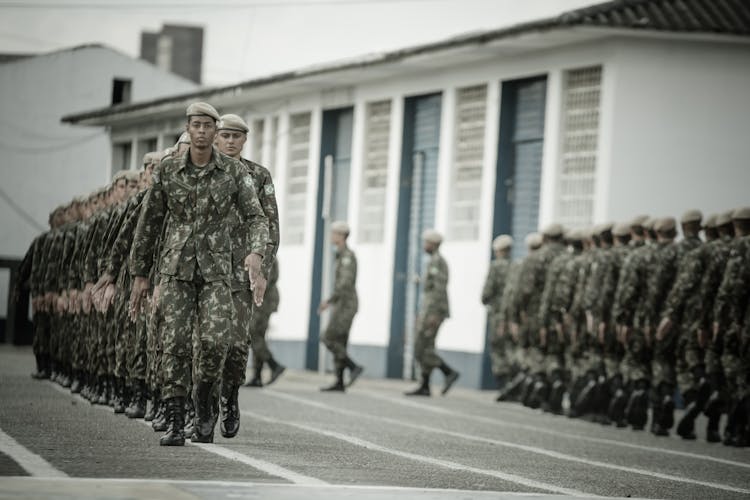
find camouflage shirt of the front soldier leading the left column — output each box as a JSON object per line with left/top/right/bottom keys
{"left": 130, "top": 148, "right": 268, "bottom": 284}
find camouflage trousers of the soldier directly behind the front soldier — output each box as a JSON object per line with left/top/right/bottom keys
{"left": 222, "top": 289, "right": 253, "bottom": 387}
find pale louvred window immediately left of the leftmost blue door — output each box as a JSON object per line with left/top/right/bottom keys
{"left": 282, "top": 113, "right": 310, "bottom": 244}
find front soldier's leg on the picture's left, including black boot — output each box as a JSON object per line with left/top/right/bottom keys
{"left": 159, "top": 279, "right": 197, "bottom": 446}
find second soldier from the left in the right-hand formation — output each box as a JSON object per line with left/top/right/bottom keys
{"left": 496, "top": 233, "right": 542, "bottom": 401}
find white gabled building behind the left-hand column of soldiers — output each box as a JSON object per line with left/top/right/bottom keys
{"left": 0, "top": 45, "right": 198, "bottom": 342}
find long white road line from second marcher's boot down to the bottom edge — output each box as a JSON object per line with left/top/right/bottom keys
{"left": 242, "top": 410, "right": 589, "bottom": 496}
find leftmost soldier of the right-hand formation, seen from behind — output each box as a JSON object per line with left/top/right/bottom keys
{"left": 482, "top": 234, "right": 513, "bottom": 391}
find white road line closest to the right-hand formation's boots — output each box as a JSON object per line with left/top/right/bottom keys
{"left": 357, "top": 390, "right": 750, "bottom": 469}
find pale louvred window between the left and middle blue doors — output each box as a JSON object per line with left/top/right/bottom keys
{"left": 359, "top": 101, "right": 391, "bottom": 243}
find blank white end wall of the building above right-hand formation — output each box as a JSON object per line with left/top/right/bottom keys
{"left": 608, "top": 40, "right": 750, "bottom": 224}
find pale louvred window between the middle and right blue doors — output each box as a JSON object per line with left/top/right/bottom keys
{"left": 448, "top": 85, "right": 487, "bottom": 240}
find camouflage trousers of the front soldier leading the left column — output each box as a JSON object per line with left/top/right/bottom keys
{"left": 159, "top": 277, "right": 234, "bottom": 399}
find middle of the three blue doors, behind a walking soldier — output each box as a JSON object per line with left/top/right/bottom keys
{"left": 386, "top": 94, "right": 441, "bottom": 378}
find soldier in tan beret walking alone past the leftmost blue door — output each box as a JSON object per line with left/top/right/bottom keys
{"left": 318, "top": 221, "right": 364, "bottom": 392}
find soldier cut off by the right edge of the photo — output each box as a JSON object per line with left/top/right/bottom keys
{"left": 713, "top": 207, "right": 750, "bottom": 447}
